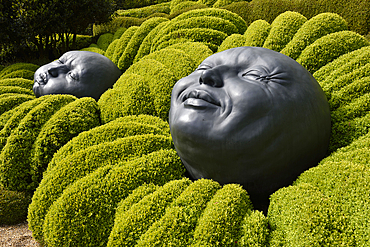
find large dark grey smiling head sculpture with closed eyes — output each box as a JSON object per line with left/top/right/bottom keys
{"left": 169, "top": 47, "right": 331, "bottom": 206}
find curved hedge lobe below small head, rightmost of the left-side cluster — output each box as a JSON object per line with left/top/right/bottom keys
{"left": 30, "top": 97, "right": 100, "bottom": 189}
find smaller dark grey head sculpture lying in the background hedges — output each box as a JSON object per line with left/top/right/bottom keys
{"left": 33, "top": 51, "right": 121, "bottom": 100}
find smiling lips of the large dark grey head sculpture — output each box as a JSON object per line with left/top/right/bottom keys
{"left": 182, "top": 89, "right": 221, "bottom": 107}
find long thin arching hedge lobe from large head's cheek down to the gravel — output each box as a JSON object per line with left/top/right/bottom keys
{"left": 28, "top": 134, "right": 173, "bottom": 240}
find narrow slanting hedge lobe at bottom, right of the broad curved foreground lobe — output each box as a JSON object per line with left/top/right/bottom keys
{"left": 107, "top": 178, "right": 191, "bottom": 247}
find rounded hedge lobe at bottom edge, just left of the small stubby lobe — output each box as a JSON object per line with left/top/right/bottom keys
{"left": 191, "top": 184, "right": 252, "bottom": 246}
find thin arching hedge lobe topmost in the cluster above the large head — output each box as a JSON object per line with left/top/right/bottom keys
{"left": 172, "top": 8, "right": 247, "bottom": 34}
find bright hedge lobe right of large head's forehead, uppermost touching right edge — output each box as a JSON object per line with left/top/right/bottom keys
{"left": 297, "top": 31, "right": 370, "bottom": 73}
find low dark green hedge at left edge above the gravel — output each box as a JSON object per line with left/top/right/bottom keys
{"left": 0, "top": 187, "right": 31, "bottom": 226}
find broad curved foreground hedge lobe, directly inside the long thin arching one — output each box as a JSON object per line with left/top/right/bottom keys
{"left": 44, "top": 150, "right": 184, "bottom": 246}
